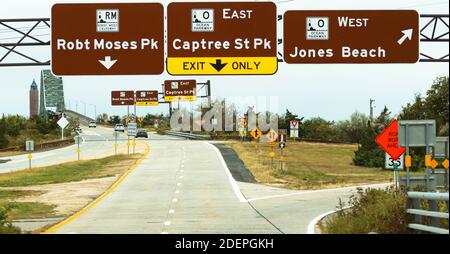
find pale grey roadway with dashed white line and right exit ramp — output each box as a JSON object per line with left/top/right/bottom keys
{"left": 47, "top": 137, "right": 385, "bottom": 234}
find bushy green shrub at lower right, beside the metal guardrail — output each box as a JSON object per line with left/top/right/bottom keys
{"left": 324, "top": 189, "right": 410, "bottom": 234}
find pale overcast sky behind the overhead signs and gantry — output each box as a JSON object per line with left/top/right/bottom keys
{"left": 0, "top": 0, "right": 449, "bottom": 120}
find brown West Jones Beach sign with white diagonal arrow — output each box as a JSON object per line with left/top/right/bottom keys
{"left": 283, "top": 10, "right": 419, "bottom": 64}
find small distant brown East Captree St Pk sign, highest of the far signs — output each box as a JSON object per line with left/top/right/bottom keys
{"left": 164, "top": 80, "right": 197, "bottom": 102}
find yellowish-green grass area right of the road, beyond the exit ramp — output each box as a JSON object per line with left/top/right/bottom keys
{"left": 227, "top": 142, "right": 393, "bottom": 189}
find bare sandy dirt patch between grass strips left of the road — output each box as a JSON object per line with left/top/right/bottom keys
{"left": 0, "top": 175, "right": 119, "bottom": 216}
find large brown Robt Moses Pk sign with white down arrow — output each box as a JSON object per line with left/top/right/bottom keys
{"left": 51, "top": 3, "right": 164, "bottom": 75}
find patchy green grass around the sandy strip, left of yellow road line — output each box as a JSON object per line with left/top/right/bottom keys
{"left": 0, "top": 154, "right": 142, "bottom": 229}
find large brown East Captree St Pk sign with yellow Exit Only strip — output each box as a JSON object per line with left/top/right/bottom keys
{"left": 167, "top": 1, "right": 278, "bottom": 75}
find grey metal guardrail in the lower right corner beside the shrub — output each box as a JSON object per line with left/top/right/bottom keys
{"left": 406, "top": 192, "right": 449, "bottom": 234}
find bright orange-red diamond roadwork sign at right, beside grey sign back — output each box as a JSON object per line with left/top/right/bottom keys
{"left": 375, "top": 120, "right": 406, "bottom": 160}
